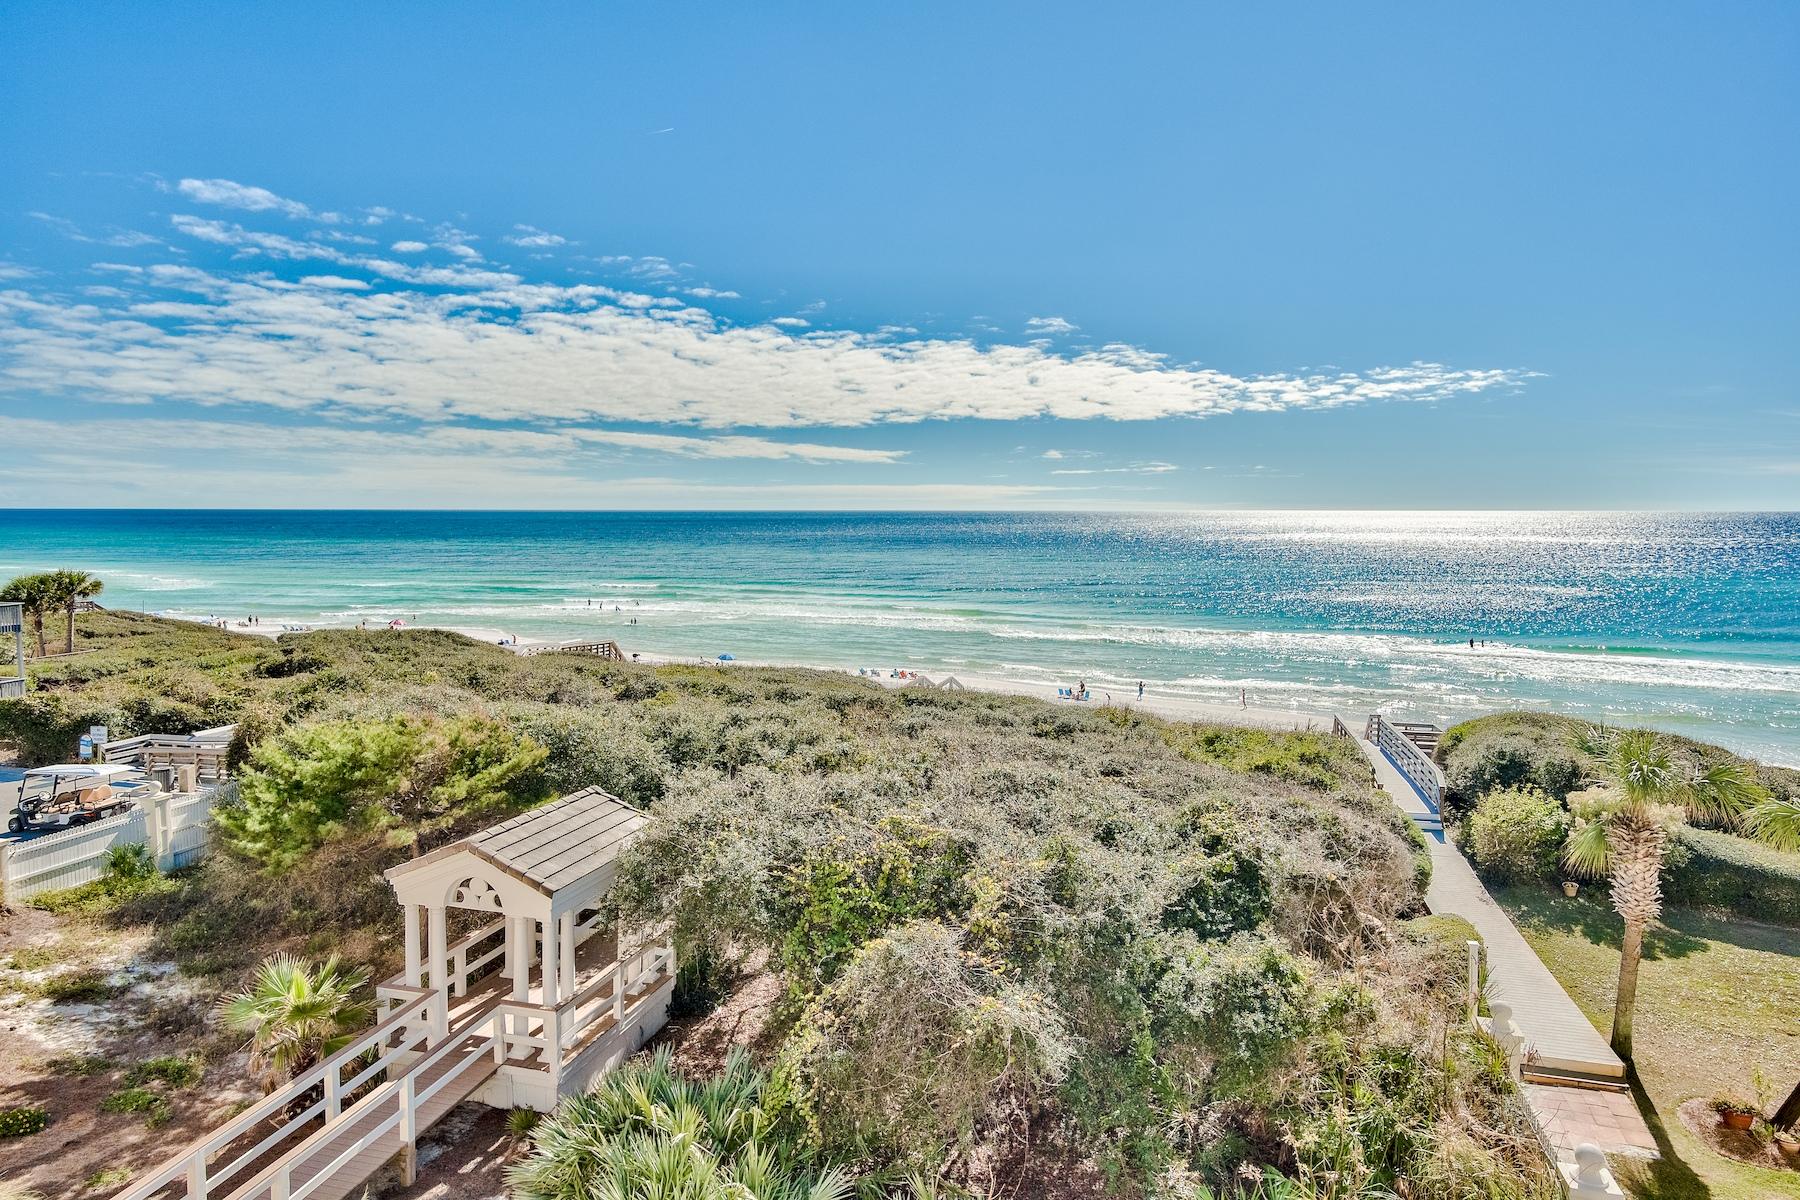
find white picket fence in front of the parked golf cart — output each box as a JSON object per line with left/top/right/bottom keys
{"left": 0, "top": 788, "right": 218, "bottom": 903}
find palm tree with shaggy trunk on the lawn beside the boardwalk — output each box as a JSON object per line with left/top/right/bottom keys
{"left": 1562, "top": 729, "right": 1769, "bottom": 1061}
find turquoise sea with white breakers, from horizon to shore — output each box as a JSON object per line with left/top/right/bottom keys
{"left": 10, "top": 511, "right": 1800, "bottom": 763}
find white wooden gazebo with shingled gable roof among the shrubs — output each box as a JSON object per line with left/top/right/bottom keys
{"left": 378, "top": 788, "right": 675, "bottom": 1110}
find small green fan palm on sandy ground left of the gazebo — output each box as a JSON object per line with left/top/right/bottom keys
{"left": 220, "top": 954, "right": 369, "bottom": 1090}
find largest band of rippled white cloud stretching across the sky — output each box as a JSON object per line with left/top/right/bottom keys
{"left": 0, "top": 262, "right": 1526, "bottom": 437}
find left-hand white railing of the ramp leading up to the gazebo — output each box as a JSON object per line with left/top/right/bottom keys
{"left": 113, "top": 988, "right": 443, "bottom": 1200}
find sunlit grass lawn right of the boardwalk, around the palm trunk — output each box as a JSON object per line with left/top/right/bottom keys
{"left": 1494, "top": 887, "right": 1800, "bottom": 1200}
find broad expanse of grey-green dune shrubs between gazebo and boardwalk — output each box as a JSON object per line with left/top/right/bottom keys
{"left": 0, "top": 613, "right": 1555, "bottom": 1200}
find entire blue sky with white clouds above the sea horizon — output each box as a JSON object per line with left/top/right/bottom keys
{"left": 0, "top": 4, "right": 1800, "bottom": 509}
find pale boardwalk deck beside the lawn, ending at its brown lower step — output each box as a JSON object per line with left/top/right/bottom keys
{"left": 1352, "top": 725, "right": 1625, "bottom": 1087}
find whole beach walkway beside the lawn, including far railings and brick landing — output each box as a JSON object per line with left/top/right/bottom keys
{"left": 1334, "top": 716, "right": 1656, "bottom": 1162}
